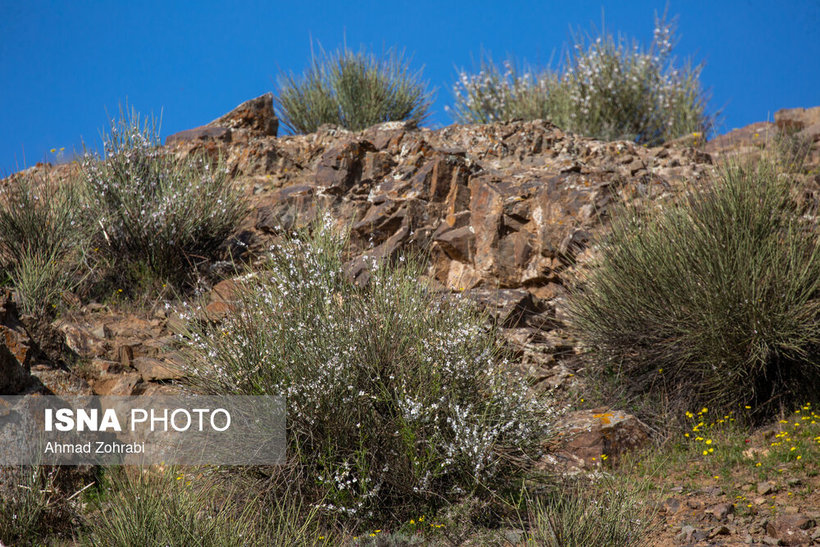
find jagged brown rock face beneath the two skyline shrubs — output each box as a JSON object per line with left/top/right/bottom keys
{"left": 171, "top": 121, "right": 712, "bottom": 299}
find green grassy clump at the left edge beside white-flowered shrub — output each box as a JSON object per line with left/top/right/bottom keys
{"left": 0, "top": 174, "right": 91, "bottom": 316}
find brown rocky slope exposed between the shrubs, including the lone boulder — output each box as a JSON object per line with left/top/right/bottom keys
{"left": 0, "top": 95, "right": 820, "bottom": 544}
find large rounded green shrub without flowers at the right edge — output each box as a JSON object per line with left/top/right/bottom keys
{"left": 573, "top": 161, "right": 820, "bottom": 422}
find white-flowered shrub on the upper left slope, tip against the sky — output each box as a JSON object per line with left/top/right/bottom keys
{"left": 82, "top": 111, "right": 246, "bottom": 292}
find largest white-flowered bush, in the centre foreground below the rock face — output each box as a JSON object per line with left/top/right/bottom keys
{"left": 179, "top": 218, "right": 550, "bottom": 522}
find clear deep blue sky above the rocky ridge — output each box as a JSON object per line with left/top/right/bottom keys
{"left": 0, "top": 0, "right": 820, "bottom": 175}
